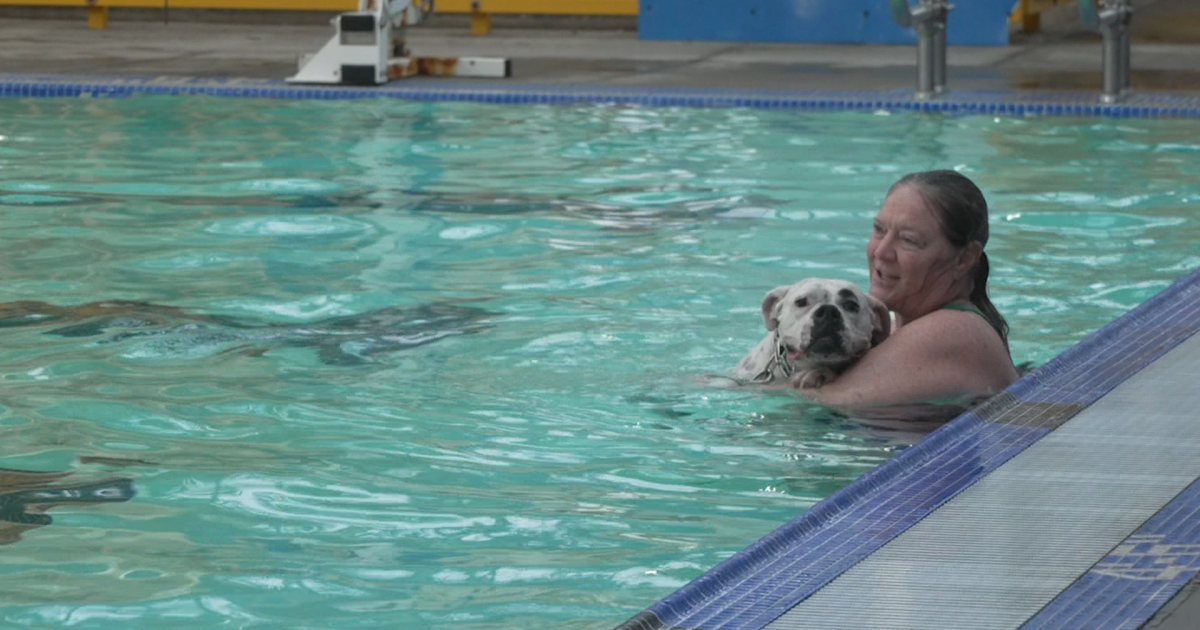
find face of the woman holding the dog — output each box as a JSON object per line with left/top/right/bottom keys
{"left": 866, "top": 186, "right": 962, "bottom": 319}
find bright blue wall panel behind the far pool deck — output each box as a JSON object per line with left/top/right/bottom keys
{"left": 638, "top": 0, "right": 1016, "bottom": 46}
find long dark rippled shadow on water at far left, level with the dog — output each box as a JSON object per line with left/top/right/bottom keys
{"left": 0, "top": 300, "right": 499, "bottom": 365}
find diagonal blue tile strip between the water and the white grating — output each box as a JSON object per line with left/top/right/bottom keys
{"left": 618, "top": 262, "right": 1200, "bottom": 630}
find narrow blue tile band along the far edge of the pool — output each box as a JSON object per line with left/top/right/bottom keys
{"left": 0, "top": 73, "right": 1200, "bottom": 118}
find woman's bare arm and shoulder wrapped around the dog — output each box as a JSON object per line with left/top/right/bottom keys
{"left": 802, "top": 311, "right": 1016, "bottom": 409}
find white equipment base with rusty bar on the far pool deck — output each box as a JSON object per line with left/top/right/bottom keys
{"left": 287, "top": 0, "right": 512, "bottom": 85}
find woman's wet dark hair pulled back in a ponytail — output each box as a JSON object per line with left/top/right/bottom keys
{"left": 888, "top": 170, "right": 1008, "bottom": 348}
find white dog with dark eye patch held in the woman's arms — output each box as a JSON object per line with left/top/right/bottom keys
{"left": 733, "top": 278, "right": 892, "bottom": 388}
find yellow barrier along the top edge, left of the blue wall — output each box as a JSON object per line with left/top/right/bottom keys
{"left": 0, "top": 0, "right": 637, "bottom": 35}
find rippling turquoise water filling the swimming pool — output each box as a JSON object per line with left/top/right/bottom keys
{"left": 0, "top": 97, "right": 1200, "bottom": 630}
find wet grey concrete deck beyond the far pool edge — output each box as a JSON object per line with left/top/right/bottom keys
{"left": 0, "top": 0, "right": 1200, "bottom": 92}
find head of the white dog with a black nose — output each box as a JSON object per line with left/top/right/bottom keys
{"left": 762, "top": 278, "right": 892, "bottom": 365}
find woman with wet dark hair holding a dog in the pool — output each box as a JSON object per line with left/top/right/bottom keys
{"left": 803, "top": 170, "right": 1018, "bottom": 418}
